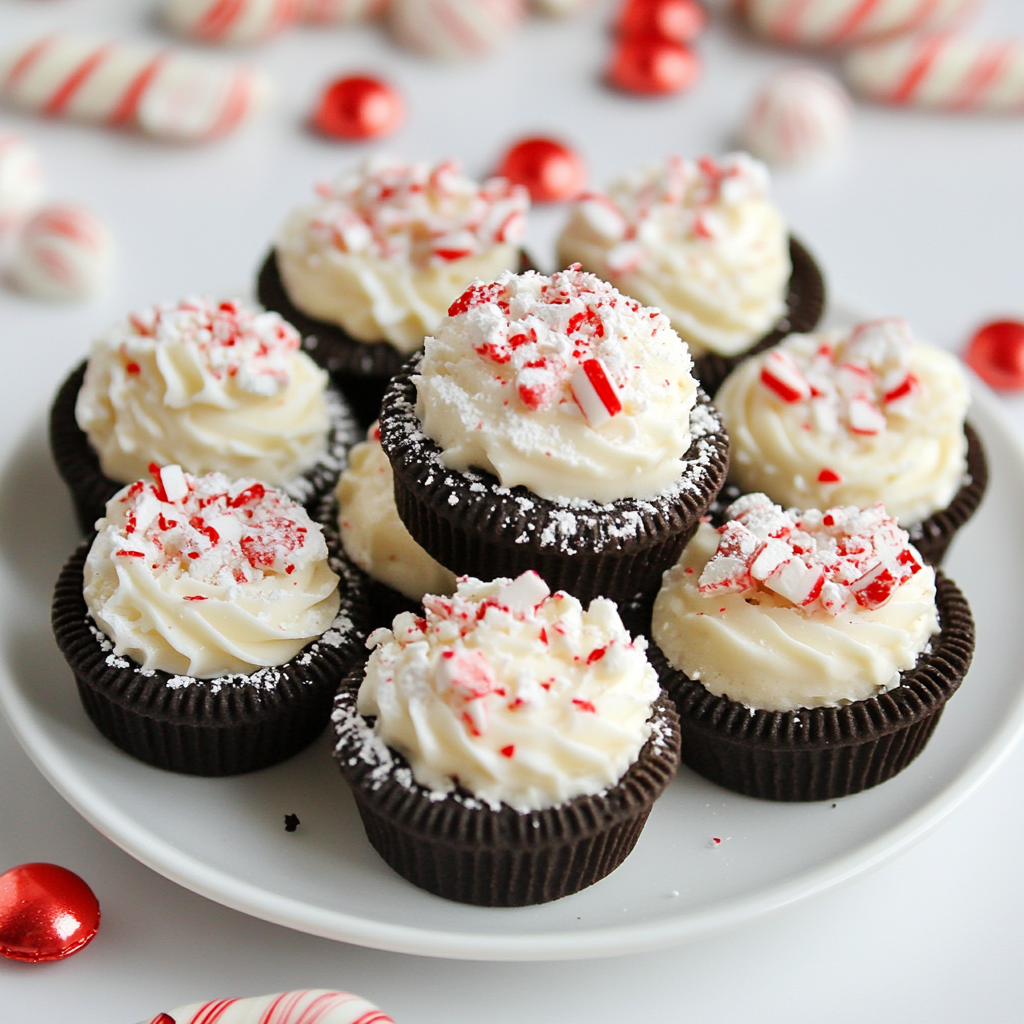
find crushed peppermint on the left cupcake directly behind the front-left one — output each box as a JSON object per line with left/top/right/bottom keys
{"left": 114, "top": 297, "right": 302, "bottom": 396}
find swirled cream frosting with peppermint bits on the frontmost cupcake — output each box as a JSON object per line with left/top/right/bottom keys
{"left": 357, "top": 572, "right": 660, "bottom": 812}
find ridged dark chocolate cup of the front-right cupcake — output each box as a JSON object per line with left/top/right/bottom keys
{"left": 648, "top": 570, "right": 975, "bottom": 801}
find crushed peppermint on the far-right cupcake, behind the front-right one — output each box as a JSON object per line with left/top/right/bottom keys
{"left": 760, "top": 316, "right": 923, "bottom": 436}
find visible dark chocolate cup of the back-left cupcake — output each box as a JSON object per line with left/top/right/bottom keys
{"left": 256, "top": 249, "right": 536, "bottom": 429}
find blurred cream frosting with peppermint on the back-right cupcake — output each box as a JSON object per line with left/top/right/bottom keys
{"left": 558, "top": 153, "right": 793, "bottom": 355}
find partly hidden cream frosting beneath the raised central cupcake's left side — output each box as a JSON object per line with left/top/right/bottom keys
{"left": 336, "top": 423, "right": 455, "bottom": 601}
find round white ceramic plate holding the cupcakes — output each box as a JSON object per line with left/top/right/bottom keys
{"left": 0, "top": 354, "right": 1024, "bottom": 959}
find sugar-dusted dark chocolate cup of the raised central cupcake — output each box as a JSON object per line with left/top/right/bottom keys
{"left": 380, "top": 353, "right": 729, "bottom": 629}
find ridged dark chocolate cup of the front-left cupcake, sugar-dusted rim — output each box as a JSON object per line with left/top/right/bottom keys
{"left": 52, "top": 541, "right": 366, "bottom": 775}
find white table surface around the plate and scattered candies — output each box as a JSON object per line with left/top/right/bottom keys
{"left": 6, "top": 0, "right": 1024, "bottom": 1024}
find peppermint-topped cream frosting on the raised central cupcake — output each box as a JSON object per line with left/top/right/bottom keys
{"left": 415, "top": 266, "right": 696, "bottom": 502}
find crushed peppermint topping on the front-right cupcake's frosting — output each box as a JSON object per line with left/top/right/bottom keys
{"left": 698, "top": 494, "right": 922, "bottom": 615}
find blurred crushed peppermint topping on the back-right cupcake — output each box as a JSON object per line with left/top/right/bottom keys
{"left": 578, "top": 153, "right": 769, "bottom": 258}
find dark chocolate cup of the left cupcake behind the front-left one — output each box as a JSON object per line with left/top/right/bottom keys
{"left": 49, "top": 362, "right": 362, "bottom": 536}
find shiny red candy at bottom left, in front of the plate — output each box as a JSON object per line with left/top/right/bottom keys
{"left": 0, "top": 864, "right": 99, "bottom": 962}
